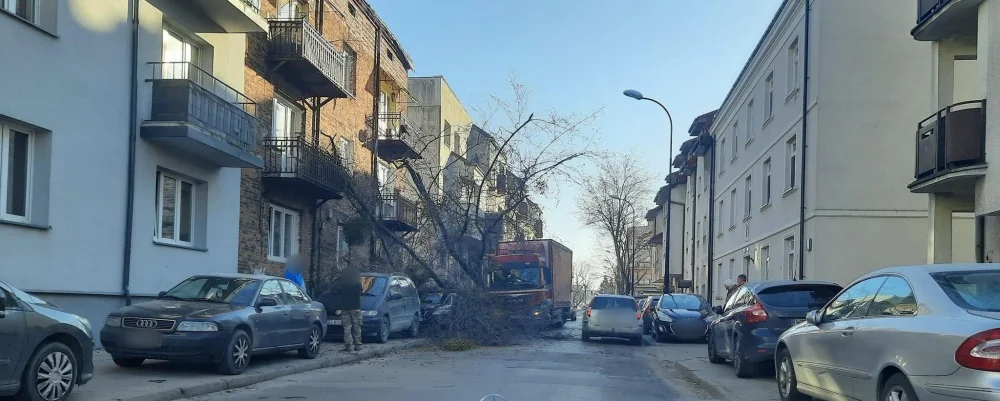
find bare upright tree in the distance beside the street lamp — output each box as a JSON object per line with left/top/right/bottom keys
{"left": 577, "top": 154, "right": 653, "bottom": 294}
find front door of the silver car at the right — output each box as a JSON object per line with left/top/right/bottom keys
{"left": 792, "top": 277, "right": 885, "bottom": 397}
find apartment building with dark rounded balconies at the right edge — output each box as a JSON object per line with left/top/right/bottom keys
{"left": 912, "top": 0, "right": 1000, "bottom": 263}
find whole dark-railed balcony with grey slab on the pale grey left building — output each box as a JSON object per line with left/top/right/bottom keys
{"left": 140, "top": 62, "right": 264, "bottom": 168}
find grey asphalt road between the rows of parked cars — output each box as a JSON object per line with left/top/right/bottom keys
{"left": 184, "top": 321, "right": 711, "bottom": 401}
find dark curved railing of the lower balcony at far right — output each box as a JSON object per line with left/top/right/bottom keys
{"left": 914, "top": 100, "right": 986, "bottom": 180}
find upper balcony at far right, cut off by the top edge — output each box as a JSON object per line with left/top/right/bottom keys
{"left": 910, "top": 0, "right": 983, "bottom": 41}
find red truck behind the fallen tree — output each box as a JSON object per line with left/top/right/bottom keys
{"left": 486, "top": 239, "right": 573, "bottom": 326}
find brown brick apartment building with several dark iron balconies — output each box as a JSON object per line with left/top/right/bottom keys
{"left": 239, "top": 0, "right": 420, "bottom": 292}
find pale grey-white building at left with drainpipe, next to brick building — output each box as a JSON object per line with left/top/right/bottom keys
{"left": 0, "top": 0, "right": 267, "bottom": 327}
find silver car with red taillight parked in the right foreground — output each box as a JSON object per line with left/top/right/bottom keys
{"left": 775, "top": 264, "right": 1000, "bottom": 400}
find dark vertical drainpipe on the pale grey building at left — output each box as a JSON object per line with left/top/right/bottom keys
{"left": 122, "top": 0, "right": 139, "bottom": 305}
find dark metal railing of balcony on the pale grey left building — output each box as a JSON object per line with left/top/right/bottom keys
{"left": 143, "top": 62, "right": 260, "bottom": 167}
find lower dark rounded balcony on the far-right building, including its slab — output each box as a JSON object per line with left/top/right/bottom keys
{"left": 909, "top": 100, "right": 986, "bottom": 193}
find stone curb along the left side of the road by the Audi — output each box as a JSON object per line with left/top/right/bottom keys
{"left": 116, "top": 339, "right": 430, "bottom": 401}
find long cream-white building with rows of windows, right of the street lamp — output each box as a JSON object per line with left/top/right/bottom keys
{"left": 699, "top": 0, "right": 973, "bottom": 304}
